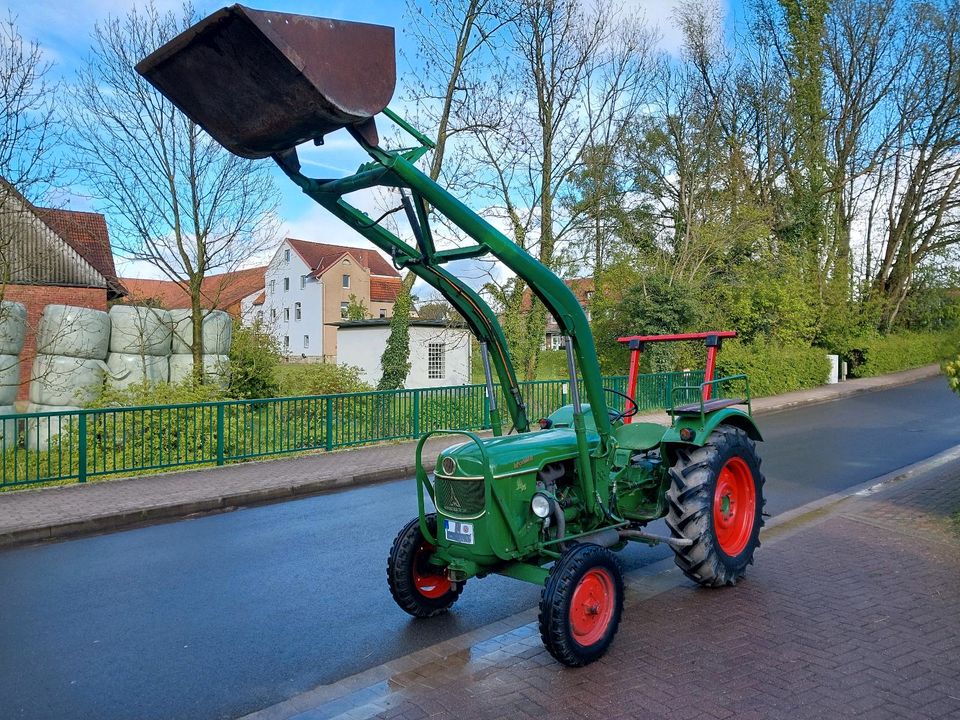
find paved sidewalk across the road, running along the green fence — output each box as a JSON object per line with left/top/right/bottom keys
{"left": 0, "top": 365, "right": 939, "bottom": 547}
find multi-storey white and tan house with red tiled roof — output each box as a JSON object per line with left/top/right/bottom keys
{"left": 262, "top": 238, "right": 400, "bottom": 362}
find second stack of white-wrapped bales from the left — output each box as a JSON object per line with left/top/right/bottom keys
{"left": 27, "top": 305, "right": 110, "bottom": 450}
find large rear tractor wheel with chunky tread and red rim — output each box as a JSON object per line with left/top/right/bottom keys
{"left": 666, "top": 425, "right": 766, "bottom": 587}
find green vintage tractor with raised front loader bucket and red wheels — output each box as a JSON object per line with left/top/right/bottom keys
{"left": 137, "top": 5, "right": 763, "bottom": 666}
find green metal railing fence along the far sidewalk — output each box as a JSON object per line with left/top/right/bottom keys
{"left": 0, "top": 371, "right": 703, "bottom": 490}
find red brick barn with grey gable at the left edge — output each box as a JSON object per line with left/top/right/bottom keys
{"left": 0, "top": 180, "right": 126, "bottom": 400}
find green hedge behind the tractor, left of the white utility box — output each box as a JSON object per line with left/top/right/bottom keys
{"left": 716, "top": 340, "right": 830, "bottom": 397}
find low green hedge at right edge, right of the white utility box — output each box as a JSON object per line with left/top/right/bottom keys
{"left": 843, "top": 332, "right": 957, "bottom": 377}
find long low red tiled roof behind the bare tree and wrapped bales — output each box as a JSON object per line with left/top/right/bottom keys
{"left": 123, "top": 267, "right": 267, "bottom": 310}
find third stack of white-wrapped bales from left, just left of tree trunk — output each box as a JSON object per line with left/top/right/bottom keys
{"left": 107, "top": 305, "right": 171, "bottom": 389}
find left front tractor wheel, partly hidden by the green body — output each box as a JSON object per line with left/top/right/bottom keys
{"left": 387, "top": 513, "right": 463, "bottom": 618}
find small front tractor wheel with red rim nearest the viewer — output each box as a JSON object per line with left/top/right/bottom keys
{"left": 540, "top": 544, "right": 623, "bottom": 667}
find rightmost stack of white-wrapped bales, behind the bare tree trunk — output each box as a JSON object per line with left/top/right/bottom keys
{"left": 170, "top": 310, "right": 233, "bottom": 390}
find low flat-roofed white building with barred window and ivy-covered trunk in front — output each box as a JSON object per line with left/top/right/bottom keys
{"left": 336, "top": 319, "right": 471, "bottom": 388}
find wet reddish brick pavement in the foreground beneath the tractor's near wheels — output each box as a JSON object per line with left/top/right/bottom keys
{"left": 249, "top": 444, "right": 960, "bottom": 720}
